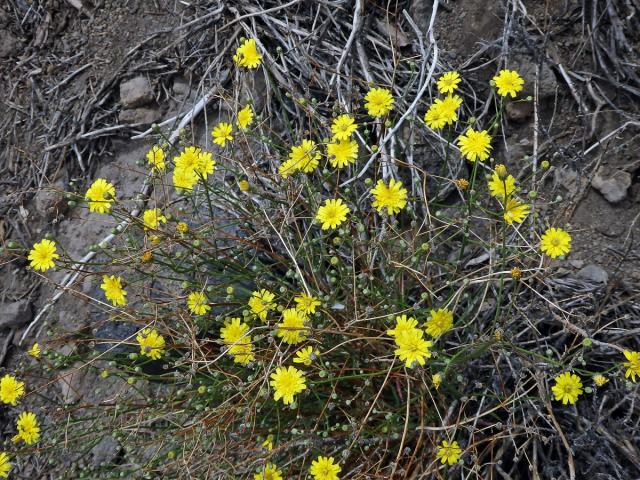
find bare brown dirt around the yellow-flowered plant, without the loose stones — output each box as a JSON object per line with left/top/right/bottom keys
{"left": 0, "top": 0, "right": 640, "bottom": 478}
